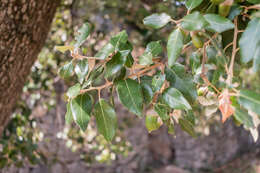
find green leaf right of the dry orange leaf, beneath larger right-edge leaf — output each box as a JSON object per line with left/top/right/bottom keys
{"left": 234, "top": 108, "right": 254, "bottom": 128}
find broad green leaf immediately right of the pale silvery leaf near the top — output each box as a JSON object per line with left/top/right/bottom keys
{"left": 181, "top": 11, "right": 208, "bottom": 31}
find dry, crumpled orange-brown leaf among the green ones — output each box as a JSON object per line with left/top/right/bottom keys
{"left": 218, "top": 89, "right": 235, "bottom": 123}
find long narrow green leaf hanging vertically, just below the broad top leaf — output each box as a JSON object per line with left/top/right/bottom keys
{"left": 167, "top": 29, "right": 183, "bottom": 67}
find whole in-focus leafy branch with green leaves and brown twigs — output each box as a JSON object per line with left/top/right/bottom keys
{"left": 57, "top": 0, "right": 260, "bottom": 141}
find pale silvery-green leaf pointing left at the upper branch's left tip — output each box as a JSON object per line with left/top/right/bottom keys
{"left": 143, "top": 13, "right": 171, "bottom": 29}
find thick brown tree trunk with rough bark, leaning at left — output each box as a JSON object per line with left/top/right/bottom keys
{"left": 0, "top": 0, "right": 59, "bottom": 135}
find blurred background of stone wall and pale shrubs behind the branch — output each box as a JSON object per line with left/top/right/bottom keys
{"left": 0, "top": 0, "right": 260, "bottom": 173}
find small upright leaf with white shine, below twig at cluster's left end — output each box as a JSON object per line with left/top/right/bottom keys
{"left": 75, "top": 59, "right": 88, "bottom": 84}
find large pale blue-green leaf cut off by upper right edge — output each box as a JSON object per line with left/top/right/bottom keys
{"left": 239, "top": 18, "right": 260, "bottom": 63}
